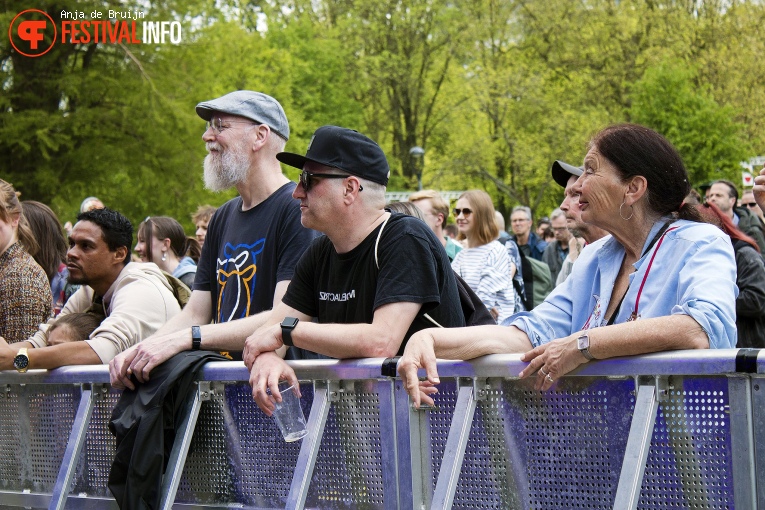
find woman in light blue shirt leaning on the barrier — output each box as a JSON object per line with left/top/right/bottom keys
{"left": 399, "top": 124, "right": 738, "bottom": 406}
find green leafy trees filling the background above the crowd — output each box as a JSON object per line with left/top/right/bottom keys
{"left": 0, "top": 0, "right": 765, "bottom": 232}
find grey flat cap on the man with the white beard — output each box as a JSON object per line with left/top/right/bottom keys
{"left": 196, "top": 90, "right": 290, "bottom": 140}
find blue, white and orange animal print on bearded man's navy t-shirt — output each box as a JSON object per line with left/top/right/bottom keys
{"left": 216, "top": 239, "right": 266, "bottom": 322}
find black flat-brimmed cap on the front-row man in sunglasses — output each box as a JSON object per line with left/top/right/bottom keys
{"left": 276, "top": 126, "right": 390, "bottom": 186}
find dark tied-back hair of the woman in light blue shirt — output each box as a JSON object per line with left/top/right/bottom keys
{"left": 590, "top": 124, "right": 703, "bottom": 222}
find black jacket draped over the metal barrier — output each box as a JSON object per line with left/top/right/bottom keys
{"left": 109, "top": 351, "right": 227, "bottom": 510}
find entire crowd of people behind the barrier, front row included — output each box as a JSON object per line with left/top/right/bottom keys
{"left": 0, "top": 91, "right": 765, "bottom": 507}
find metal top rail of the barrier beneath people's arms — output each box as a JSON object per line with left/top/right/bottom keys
{"left": 0, "top": 349, "right": 765, "bottom": 384}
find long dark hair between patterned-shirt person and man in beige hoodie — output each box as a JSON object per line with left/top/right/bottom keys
{"left": 21, "top": 200, "right": 68, "bottom": 281}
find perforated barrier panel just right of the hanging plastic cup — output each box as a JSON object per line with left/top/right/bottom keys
{"left": 306, "top": 381, "right": 384, "bottom": 509}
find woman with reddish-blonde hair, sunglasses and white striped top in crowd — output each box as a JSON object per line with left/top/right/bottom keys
{"left": 452, "top": 190, "right": 516, "bottom": 322}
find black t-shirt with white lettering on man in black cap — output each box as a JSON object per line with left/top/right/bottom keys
{"left": 283, "top": 213, "right": 465, "bottom": 353}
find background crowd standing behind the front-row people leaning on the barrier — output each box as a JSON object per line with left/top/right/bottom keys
{"left": 0, "top": 143, "right": 765, "bottom": 360}
